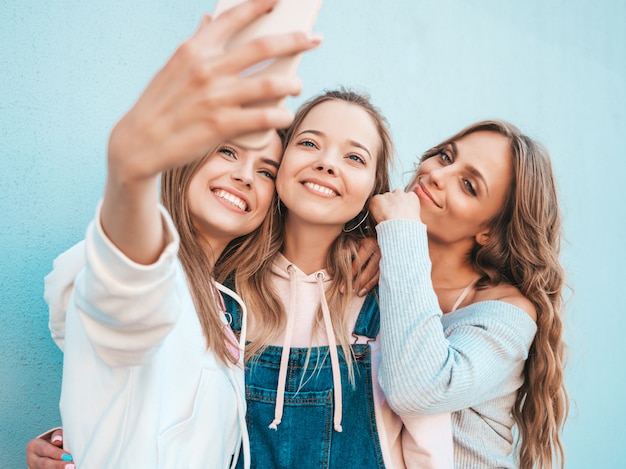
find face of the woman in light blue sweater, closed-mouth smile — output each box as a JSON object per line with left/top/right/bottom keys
{"left": 409, "top": 131, "right": 512, "bottom": 245}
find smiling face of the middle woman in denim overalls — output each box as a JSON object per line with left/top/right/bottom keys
{"left": 276, "top": 100, "right": 381, "bottom": 231}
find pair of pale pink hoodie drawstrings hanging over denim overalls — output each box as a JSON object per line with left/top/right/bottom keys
{"left": 269, "top": 265, "right": 343, "bottom": 432}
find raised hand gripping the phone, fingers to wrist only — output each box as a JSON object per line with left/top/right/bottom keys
{"left": 108, "top": 0, "right": 321, "bottom": 181}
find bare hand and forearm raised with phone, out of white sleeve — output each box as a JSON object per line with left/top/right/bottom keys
{"left": 102, "top": 0, "right": 320, "bottom": 263}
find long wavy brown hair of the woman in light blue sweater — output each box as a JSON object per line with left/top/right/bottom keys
{"left": 412, "top": 120, "right": 569, "bottom": 469}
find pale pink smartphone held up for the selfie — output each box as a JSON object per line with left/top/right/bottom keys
{"left": 213, "top": 0, "right": 322, "bottom": 148}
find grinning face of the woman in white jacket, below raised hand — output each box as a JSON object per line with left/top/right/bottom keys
{"left": 187, "top": 130, "right": 282, "bottom": 251}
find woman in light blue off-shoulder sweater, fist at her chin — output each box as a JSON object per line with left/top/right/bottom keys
{"left": 370, "top": 121, "right": 568, "bottom": 469}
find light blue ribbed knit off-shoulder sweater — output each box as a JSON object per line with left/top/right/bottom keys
{"left": 376, "top": 220, "right": 536, "bottom": 468}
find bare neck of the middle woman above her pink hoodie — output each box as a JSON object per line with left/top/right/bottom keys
{"left": 281, "top": 216, "right": 341, "bottom": 275}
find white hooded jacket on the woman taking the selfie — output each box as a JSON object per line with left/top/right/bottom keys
{"left": 44, "top": 209, "right": 249, "bottom": 469}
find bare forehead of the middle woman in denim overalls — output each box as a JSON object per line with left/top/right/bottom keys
{"left": 295, "top": 100, "right": 381, "bottom": 156}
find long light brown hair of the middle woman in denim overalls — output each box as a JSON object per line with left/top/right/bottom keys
{"left": 216, "top": 88, "right": 394, "bottom": 372}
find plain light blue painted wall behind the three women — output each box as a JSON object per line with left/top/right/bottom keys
{"left": 0, "top": 0, "right": 626, "bottom": 462}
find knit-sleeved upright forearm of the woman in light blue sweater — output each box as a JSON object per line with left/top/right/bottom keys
{"left": 377, "top": 220, "right": 451, "bottom": 412}
